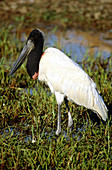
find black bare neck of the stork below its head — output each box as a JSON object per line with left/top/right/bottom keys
{"left": 26, "top": 45, "right": 43, "bottom": 77}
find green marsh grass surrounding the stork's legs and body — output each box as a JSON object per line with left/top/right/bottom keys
{"left": 0, "top": 29, "right": 112, "bottom": 169}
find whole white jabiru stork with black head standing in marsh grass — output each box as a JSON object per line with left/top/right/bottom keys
{"left": 9, "top": 29, "right": 108, "bottom": 135}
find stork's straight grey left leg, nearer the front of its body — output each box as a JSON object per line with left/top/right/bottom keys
{"left": 56, "top": 104, "right": 61, "bottom": 135}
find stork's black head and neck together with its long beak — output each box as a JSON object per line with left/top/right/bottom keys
{"left": 9, "top": 29, "right": 44, "bottom": 77}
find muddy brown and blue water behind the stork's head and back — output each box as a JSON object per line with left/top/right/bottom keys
{"left": 20, "top": 28, "right": 112, "bottom": 62}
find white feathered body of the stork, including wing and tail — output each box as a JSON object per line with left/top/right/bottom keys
{"left": 38, "top": 48, "right": 107, "bottom": 120}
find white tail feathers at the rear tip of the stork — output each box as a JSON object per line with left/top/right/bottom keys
{"left": 94, "top": 89, "right": 108, "bottom": 121}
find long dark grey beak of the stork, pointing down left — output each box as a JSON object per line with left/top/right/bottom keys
{"left": 9, "top": 40, "right": 34, "bottom": 76}
